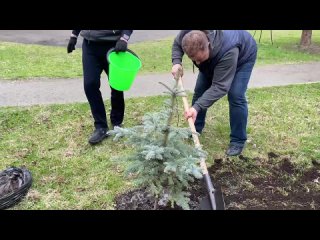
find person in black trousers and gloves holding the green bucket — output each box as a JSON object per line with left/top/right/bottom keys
{"left": 67, "top": 30, "right": 133, "bottom": 144}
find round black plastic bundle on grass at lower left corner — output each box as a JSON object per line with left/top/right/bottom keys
{"left": 0, "top": 167, "right": 32, "bottom": 209}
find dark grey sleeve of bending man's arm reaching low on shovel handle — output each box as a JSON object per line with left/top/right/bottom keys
{"left": 193, "top": 48, "right": 239, "bottom": 112}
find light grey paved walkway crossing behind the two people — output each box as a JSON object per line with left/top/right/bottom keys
{"left": 0, "top": 62, "right": 320, "bottom": 106}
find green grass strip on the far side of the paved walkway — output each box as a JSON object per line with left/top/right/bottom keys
{"left": 0, "top": 30, "right": 320, "bottom": 79}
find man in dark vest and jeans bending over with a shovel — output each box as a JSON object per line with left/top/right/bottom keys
{"left": 171, "top": 30, "right": 257, "bottom": 156}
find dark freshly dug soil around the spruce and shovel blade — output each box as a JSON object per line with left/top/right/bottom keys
{"left": 115, "top": 152, "right": 320, "bottom": 210}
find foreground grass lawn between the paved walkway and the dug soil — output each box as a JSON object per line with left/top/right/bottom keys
{"left": 0, "top": 83, "right": 320, "bottom": 209}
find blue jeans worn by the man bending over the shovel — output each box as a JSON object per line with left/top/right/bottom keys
{"left": 192, "top": 61, "right": 255, "bottom": 147}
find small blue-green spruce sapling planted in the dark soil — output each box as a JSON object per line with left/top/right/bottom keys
{"left": 109, "top": 83, "right": 206, "bottom": 209}
